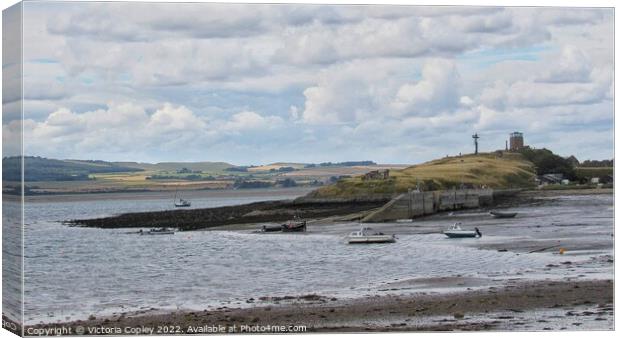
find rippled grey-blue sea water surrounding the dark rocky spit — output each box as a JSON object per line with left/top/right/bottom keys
{"left": 10, "top": 192, "right": 613, "bottom": 324}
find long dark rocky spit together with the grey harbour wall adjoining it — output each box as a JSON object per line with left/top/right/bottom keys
{"left": 65, "top": 189, "right": 519, "bottom": 231}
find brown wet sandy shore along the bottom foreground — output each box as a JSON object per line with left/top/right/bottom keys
{"left": 27, "top": 279, "right": 613, "bottom": 334}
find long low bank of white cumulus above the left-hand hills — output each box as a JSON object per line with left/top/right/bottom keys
{"left": 3, "top": 103, "right": 284, "bottom": 159}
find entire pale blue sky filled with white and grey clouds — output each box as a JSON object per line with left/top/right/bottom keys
{"left": 3, "top": 2, "right": 613, "bottom": 164}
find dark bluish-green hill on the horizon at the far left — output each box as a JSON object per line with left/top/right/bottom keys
{"left": 2, "top": 156, "right": 142, "bottom": 182}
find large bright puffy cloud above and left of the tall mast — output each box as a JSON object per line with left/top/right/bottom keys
{"left": 303, "top": 59, "right": 460, "bottom": 124}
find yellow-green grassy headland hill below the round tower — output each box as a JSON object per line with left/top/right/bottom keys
{"left": 310, "top": 153, "right": 535, "bottom": 197}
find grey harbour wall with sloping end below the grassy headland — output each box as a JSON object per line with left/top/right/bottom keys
{"left": 362, "top": 189, "right": 502, "bottom": 223}
